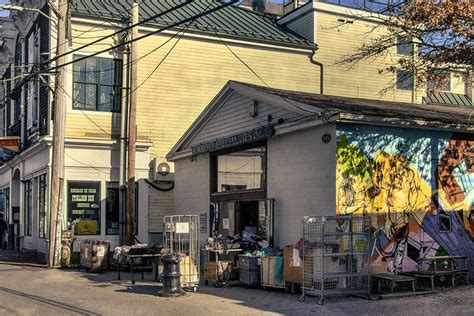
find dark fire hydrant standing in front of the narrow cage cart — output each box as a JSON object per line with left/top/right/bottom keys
{"left": 158, "top": 254, "right": 184, "bottom": 297}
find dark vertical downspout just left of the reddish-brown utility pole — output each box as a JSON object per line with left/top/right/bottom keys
{"left": 119, "top": 43, "right": 133, "bottom": 245}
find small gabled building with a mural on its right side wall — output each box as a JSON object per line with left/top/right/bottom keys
{"left": 168, "top": 82, "right": 474, "bottom": 279}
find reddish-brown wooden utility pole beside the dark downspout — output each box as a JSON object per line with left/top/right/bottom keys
{"left": 125, "top": 0, "right": 139, "bottom": 246}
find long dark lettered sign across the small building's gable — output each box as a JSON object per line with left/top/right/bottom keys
{"left": 192, "top": 126, "right": 274, "bottom": 155}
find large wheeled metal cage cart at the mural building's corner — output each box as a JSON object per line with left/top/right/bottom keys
{"left": 299, "top": 216, "right": 370, "bottom": 305}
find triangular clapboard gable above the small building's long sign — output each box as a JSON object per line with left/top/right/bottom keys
{"left": 185, "top": 93, "right": 302, "bottom": 146}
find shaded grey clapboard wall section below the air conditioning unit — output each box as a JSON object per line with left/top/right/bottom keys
{"left": 148, "top": 186, "right": 174, "bottom": 233}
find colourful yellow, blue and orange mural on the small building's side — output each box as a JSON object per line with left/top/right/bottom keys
{"left": 336, "top": 124, "right": 474, "bottom": 278}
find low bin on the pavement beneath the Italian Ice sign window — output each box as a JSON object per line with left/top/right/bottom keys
{"left": 81, "top": 240, "right": 110, "bottom": 272}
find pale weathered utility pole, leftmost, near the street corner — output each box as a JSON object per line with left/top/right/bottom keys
{"left": 48, "top": 0, "right": 68, "bottom": 268}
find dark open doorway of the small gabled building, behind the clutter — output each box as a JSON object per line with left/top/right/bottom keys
{"left": 214, "top": 199, "right": 274, "bottom": 246}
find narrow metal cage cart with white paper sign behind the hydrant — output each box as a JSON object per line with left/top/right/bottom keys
{"left": 163, "top": 215, "right": 200, "bottom": 292}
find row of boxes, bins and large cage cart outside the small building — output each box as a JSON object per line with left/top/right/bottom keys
{"left": 204, "top": 216, "right": 371, "bottom": 304}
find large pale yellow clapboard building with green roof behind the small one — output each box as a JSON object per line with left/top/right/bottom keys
{"left": 0, "top": 0, "right": 470, "bottom": 251}
